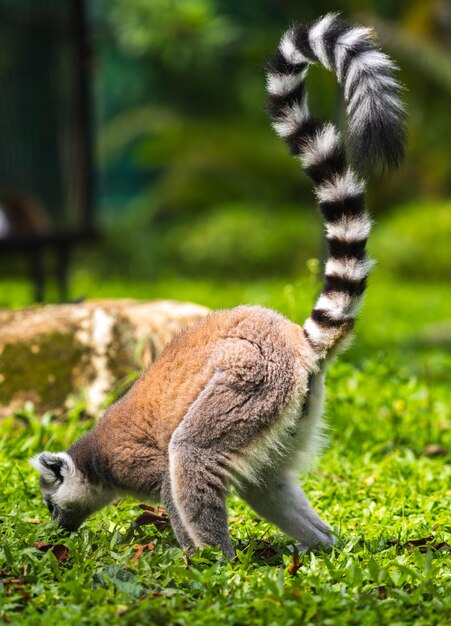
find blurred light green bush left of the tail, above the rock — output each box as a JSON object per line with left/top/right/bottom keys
{"left": 96, "top": 202, "right": 321, "bottom": 279}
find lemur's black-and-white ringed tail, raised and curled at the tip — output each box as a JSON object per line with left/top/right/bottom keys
{"left": 267, "top": 14, "right": 405, "bottom": 357}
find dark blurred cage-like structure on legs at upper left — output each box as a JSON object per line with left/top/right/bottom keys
{"left": 0, "top": 0, "right": 95, "bottom": 301}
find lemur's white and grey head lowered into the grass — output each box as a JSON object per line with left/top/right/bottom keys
{"left": 30, "top": 452, "right": 111, "bottom": 531}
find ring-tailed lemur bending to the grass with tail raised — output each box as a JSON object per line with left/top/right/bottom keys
{"left": 31, "top": 14, "right": 404, "bottom": 557}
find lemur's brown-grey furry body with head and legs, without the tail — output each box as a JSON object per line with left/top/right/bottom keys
{"left": 37, "top": 306, "right": 333, "bottom": 557}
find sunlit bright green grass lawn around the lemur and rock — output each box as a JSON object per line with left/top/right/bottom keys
{"left": 0, "top": 272, "right": 451, "bottom": 626}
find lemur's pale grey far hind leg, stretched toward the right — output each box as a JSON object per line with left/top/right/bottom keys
{"left": 237, "top": 472, "right": 335, "bottom": 550}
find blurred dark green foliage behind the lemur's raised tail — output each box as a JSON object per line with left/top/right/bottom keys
{"left": 90, "top": 0, "right": 451, "bottom": 278}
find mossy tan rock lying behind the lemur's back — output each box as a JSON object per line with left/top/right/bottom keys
{"left": 0, "top": 300, "right": 208, "bottom": 417}
